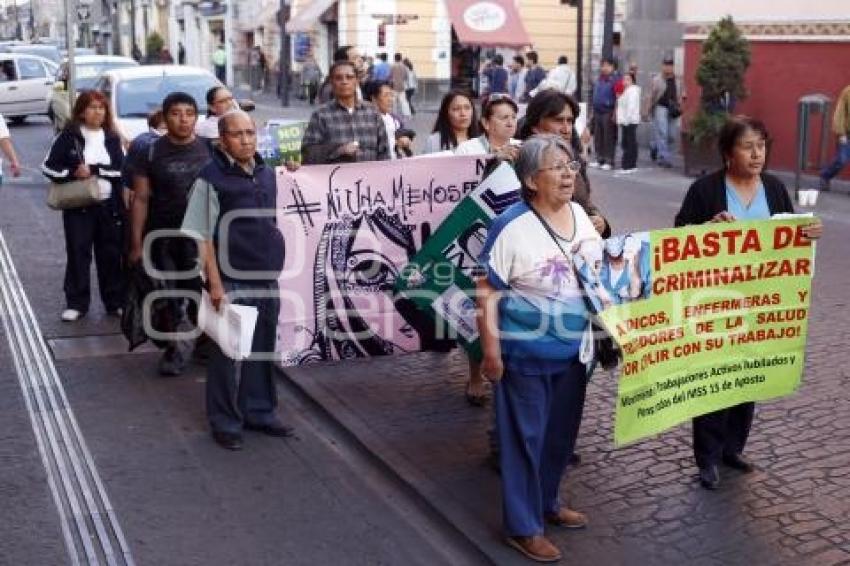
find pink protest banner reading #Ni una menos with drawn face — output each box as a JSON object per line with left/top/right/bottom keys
{"left": 277, "top": 156, "right": 484, "bottom": 366}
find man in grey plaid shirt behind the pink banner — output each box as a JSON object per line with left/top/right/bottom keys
{"left": 301, "top": 61, "right": 390, "bottom": 165}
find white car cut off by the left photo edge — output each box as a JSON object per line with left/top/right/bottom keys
{"left": 0, "top": 53, "right": 58, "bottom": 123}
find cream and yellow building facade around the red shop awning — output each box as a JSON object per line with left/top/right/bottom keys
{"left": 287, "top": 0, "right": 616, "bottom": 101}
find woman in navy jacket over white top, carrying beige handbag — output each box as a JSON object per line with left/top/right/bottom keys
{"left": 41, "top": 91, "right": 126, "bottom": 322}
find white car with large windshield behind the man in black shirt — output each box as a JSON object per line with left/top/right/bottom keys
{"left": 94, "top": 65, "right": 253, "bottom": 140}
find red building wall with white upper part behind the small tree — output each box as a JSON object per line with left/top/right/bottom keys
{"left": 678, "top": 0, "right": 850, "bottom": 175}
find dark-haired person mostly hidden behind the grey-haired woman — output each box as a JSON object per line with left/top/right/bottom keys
{"left": 519, "top": 89, "right": 611, "bottom": 238}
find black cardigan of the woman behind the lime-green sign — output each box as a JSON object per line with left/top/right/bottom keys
{"left": 674, "top": 169, "right": 794, "bottom": 226}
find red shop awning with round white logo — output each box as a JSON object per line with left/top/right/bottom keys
{"left": 445, "top": 0, "right": 531, "bottom": 47}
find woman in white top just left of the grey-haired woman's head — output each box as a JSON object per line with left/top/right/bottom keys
{"left": 455, "top": 94, "right": 520, "bottom": 161}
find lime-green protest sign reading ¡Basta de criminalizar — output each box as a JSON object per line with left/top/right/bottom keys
{"left": 588, "top": 218, "right": 814, "bottom": 445}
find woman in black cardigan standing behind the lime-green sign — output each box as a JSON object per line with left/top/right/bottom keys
{"left": 675, "top": 116, "right": 823, "bottom": 489}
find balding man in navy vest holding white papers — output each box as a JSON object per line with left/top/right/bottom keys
{"left": 182, "top": 110, "right": 292, "bottom": 450}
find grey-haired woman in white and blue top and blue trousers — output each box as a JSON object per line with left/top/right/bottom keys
{"left": 477, "top": 134, "right": 599, "bottom": 562}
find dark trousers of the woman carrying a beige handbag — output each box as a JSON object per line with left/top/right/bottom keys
{"left": 62, "top": 202, "right": 125, "bottom": 313}
